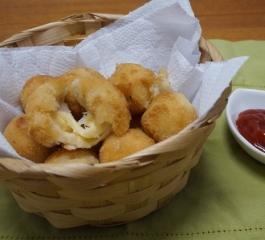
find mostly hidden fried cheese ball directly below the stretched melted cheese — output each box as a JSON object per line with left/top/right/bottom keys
{"left": 44, "top": 148, "right": 99, "bottom": 164}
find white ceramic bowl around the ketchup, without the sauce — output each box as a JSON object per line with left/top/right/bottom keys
{"left": 226, "top": 88, "right": 265, "bottom": 164}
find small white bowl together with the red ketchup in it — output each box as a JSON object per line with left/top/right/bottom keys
{"left": 226, "top": 88, "right": 265, "bottom": 164}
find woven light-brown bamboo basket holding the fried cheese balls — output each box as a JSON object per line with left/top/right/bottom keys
{"left": 0, "top": 13, "right": 228, "bottom": 228}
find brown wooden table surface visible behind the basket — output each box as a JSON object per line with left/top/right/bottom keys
{"left": 0, "top": 0, "right": 265, "bottom": 42}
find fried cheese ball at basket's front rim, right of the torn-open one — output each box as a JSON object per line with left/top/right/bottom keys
{"left": 99, "top": 128, "right": 155, "bottom": 163}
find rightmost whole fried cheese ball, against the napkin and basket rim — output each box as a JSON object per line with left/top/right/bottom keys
{"left": 141, "top": 92, "right": 198, "bottom": 142}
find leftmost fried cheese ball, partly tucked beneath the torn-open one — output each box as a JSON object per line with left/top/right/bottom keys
{"left": 3, "top": 114, "right": 55, "bottom": 163}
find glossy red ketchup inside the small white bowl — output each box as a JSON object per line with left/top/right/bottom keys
{"left": 236, "top": 109, "right": 265, "bottom": 152}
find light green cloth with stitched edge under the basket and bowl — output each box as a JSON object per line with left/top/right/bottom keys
{"left": 0, "top": 40, "right": 265, "bottom": 240}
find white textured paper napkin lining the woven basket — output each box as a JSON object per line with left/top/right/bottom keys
{"left": 0, "top": 0, "right": 247, "bottom": 159}
